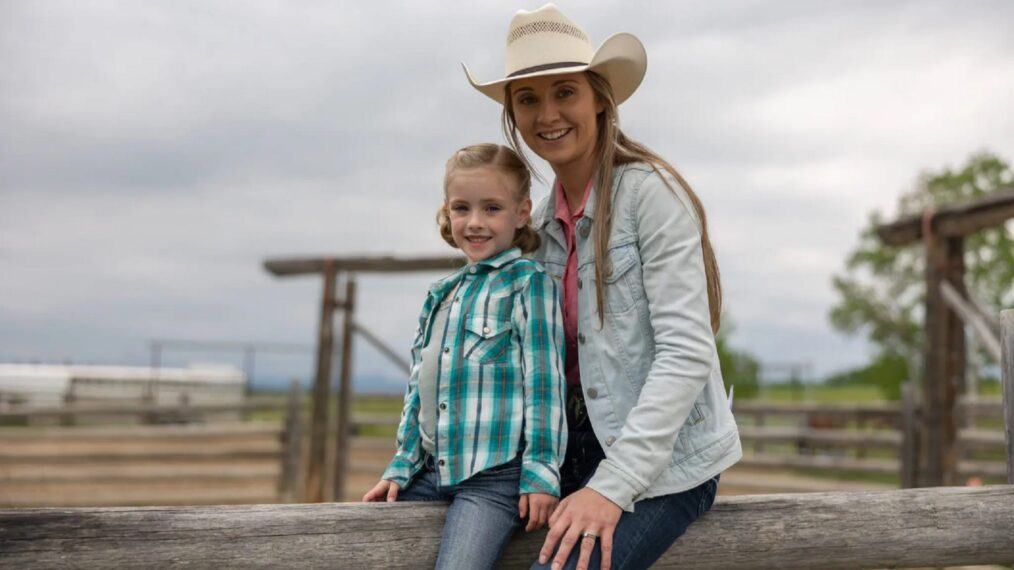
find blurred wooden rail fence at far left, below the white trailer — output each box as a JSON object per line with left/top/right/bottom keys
{"left": 0, "top": 386, "right": 303, "bottom": 507}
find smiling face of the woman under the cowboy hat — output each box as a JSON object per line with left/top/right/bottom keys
{"left": 510, "top": 73, "right": 603, "bottom": 168}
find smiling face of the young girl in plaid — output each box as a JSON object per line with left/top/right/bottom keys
{"left": 444, "top": 166, "right": 531, "bottom": 263}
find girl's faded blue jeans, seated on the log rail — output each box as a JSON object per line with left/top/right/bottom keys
{"left": 397, "top": 455, "right": 521, "bottom": 569}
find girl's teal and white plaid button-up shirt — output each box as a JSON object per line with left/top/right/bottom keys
{"left": 383, "top": 247, "right": 567, "bottom": 497}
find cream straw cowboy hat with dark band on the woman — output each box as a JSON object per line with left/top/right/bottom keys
{"left": 461, "top": 4, "right": 648, "bottom": 104}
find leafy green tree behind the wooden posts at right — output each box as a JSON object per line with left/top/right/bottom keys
{"left": 829, "top": 153, "right": 1014, "bottom": 389}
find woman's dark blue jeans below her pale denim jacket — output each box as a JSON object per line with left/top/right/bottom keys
{"left": 531, "top": 431, "right": 718, "bottom": 570}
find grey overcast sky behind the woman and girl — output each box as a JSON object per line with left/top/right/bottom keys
{"left": 0, "top": 0, "right": 1014, "bottom": 389}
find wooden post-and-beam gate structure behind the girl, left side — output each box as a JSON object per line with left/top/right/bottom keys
{"left": 264, "top": 256, "right": 465, "bottom": 502}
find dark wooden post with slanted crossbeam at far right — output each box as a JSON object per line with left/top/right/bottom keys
{"left": 877, "top": 188, "right": 1014, "bottom": 487}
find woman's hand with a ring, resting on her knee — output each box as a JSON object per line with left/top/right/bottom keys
{"left": 538, "top": 487, "right": 624, "bottom": 570}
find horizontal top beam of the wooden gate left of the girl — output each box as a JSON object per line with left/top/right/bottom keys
{"left": 264, "top": 256, "right": 467, "bottom": 277}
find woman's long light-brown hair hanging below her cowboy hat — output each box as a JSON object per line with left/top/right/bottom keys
{"left": 501, "top": 71, "right": 722, "bottom": 334}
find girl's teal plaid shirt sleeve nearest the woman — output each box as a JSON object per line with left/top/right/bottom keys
{"left": 513, "top": 271, "right": 567, "bottom": 497}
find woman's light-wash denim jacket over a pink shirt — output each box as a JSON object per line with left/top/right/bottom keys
{"left": 532, "top": 163, "right": 742, "bottom": 511}
